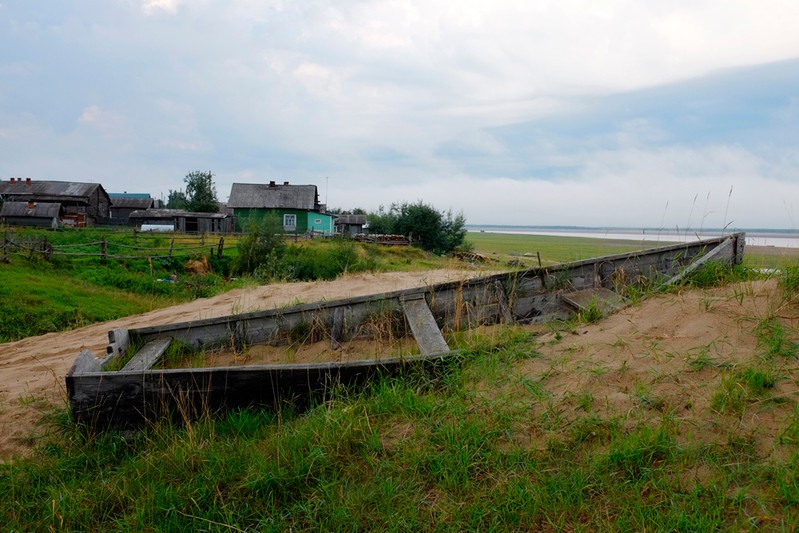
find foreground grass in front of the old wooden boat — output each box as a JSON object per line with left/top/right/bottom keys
{"left": 6, "top": 328, "right": 799, "bottom": 531}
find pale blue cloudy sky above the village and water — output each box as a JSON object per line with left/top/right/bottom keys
{"left": 0, "top": 0, "right": 799, "bottom": 230}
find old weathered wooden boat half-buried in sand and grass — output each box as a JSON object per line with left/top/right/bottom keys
{"left": 66, "top": 233, "right": 745, "bottom": 427}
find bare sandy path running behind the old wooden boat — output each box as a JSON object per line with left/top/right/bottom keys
{"left": 0, "top": 270, "right": 488, "bottom": 460}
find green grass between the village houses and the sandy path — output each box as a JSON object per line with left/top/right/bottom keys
{"left": 0, "top": 228, "right": 458, "bottom": 342}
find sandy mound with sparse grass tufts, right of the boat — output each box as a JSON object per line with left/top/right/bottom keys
{"left": 510, "top": 279, "right": 799, "bottom": 460}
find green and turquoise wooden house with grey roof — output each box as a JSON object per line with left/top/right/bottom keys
{"left": 227, "top": 181, "right": 334, "bottom": 235}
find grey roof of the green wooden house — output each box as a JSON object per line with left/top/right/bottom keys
{"left": 227, "top": 183, "right": 319, "bottom": 211}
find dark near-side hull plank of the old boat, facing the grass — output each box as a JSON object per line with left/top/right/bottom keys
{"left": 66, "top": 354, "right": 456, "bottom": 429}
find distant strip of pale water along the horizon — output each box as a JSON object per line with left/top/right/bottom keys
{"left": 466, "top": 224, "right": 799, "bottom": 248}
